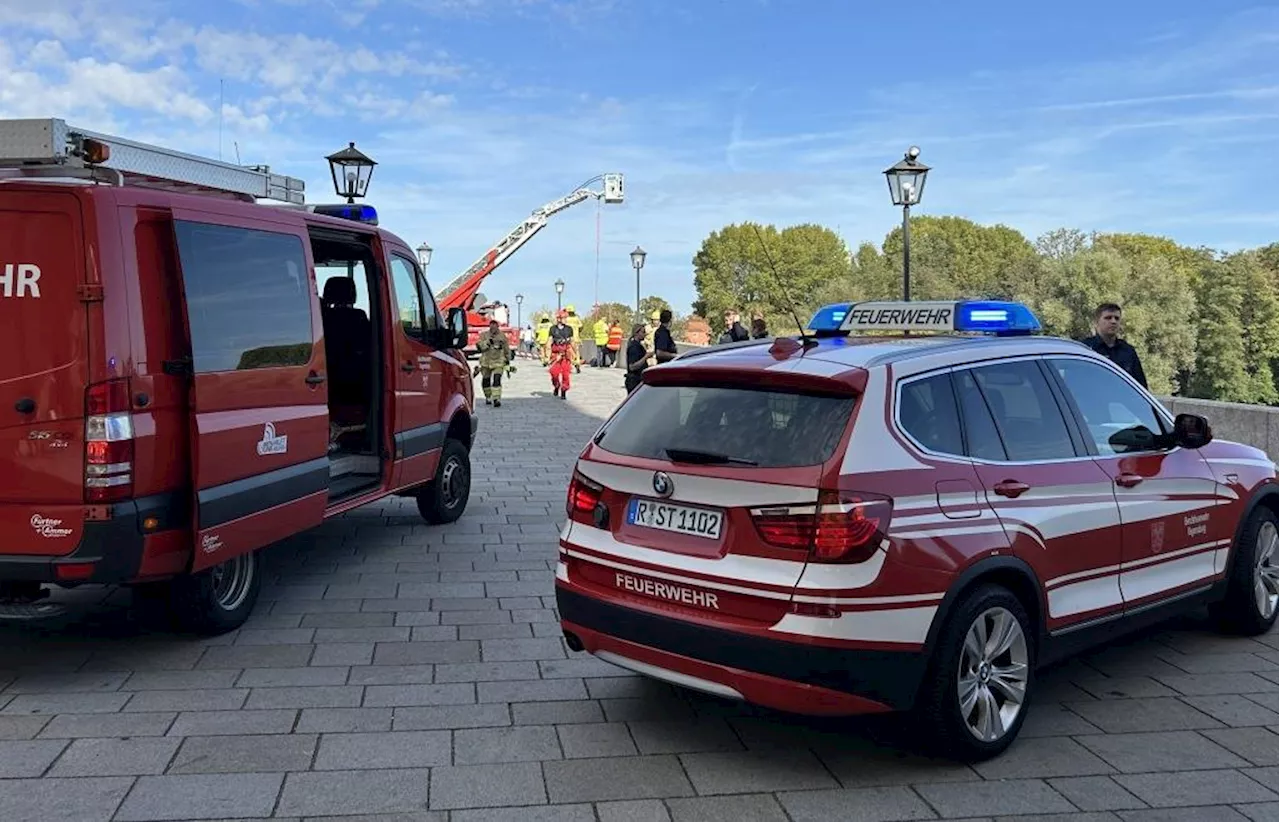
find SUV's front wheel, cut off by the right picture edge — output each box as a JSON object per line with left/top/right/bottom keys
{"left": 1210, "top": 506, "right": 1280, "bottom": 636}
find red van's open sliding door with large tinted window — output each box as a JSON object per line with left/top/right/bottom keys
{"left": 174, "top": 211, "right": 329, "bottom": 571}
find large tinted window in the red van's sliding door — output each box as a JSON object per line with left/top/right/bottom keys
{"left": 174, "top": 220, "right": 311, "bottom": 371}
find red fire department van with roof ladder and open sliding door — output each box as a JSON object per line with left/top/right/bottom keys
{"left": 0, "top": 119, "right": 476, "bottom": 634}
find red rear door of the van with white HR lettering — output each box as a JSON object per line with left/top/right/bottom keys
{"left": 0, "top": 187, "right": 90, "bottom": 556}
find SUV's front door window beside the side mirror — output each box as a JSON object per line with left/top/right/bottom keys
{"left": 1051, "top": 360, "right": 1165, "bottom": 455}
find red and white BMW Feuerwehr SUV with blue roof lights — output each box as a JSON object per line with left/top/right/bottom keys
{"left": 556, "top": 302, "right": 1280, "bottom": 759}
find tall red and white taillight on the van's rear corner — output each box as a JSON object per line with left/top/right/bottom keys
{"left": 84, "top": 379, "right": 133, "bottom": 503}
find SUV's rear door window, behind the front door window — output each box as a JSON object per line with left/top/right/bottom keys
{"left": 973, "top": 360, "right": 1076, "bottom": 462}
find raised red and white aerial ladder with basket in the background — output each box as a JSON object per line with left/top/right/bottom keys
{"left": 436, "top": 174, "right": 622, "bottom": 351}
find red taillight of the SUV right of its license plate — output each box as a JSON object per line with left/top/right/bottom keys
{"left": 751, "top": 490, "right": 893, "bottom": 562}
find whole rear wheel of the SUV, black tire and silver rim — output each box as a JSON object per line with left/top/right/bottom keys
{"left": 915, "top": 584, "right": 1036, "bottom": 762}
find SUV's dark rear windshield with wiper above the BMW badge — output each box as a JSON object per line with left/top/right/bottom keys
{"left": 596, "top": 385, "right": 854, "bottom": 469}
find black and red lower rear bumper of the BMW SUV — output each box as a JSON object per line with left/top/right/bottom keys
{"left": 556, "top": 584, "right": 928, "bottom": 716}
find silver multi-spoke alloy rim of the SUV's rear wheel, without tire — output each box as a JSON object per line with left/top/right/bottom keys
{"left": 956, "top": 607, "right": 1028, "bottom": 743}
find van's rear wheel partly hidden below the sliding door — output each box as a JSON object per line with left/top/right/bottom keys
{"left": 169, "top": 551, "right": 262, "bottom": 636}
